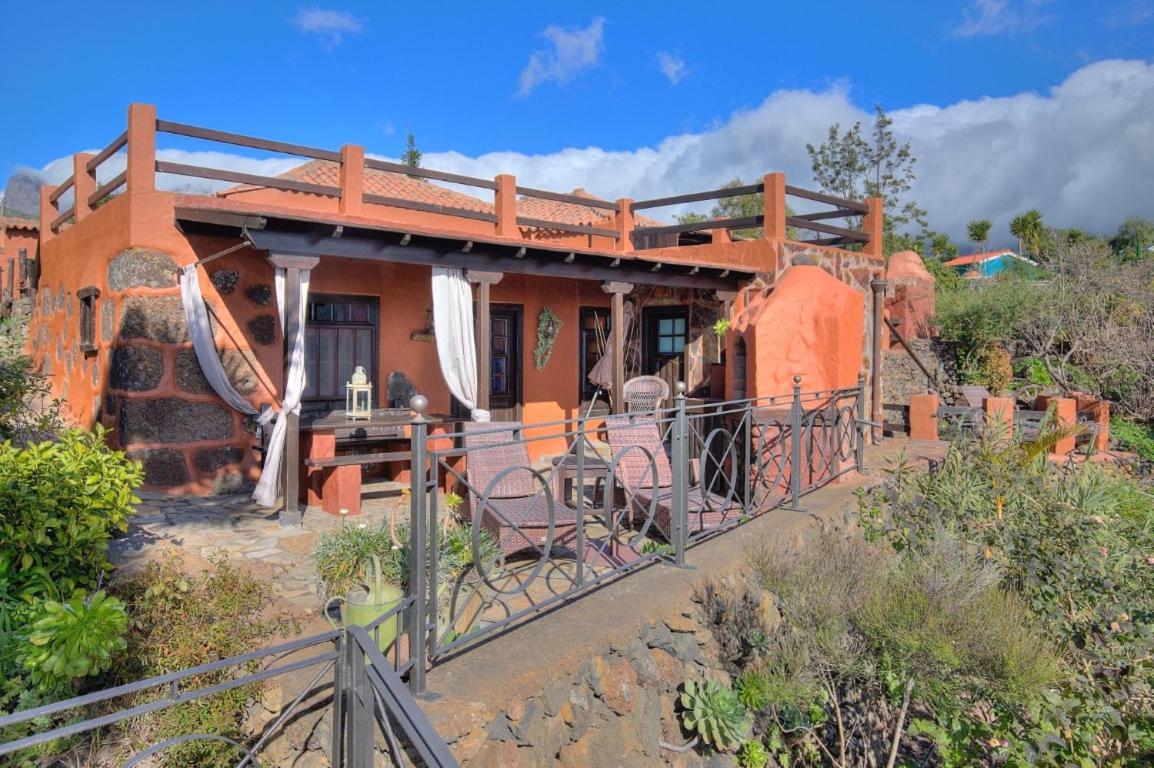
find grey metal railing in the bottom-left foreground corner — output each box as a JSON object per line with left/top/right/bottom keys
{"left": 0, "top": 598, "right": 457, "bottom": 768}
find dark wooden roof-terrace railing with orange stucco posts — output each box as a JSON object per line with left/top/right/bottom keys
{"left": 40, "top": 104, "right": 882, "bottom": 256}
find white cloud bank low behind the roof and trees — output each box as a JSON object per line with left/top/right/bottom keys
{"left": 31, "top": 60, "right": 1154, "bottom": 246}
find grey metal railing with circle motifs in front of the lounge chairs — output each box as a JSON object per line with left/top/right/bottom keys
{"left": 409, "top": 377, "right": 868, "bottom": 691}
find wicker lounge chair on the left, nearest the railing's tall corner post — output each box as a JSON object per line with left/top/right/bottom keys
{"left": 464, "top": 421, "right": 577, "bottom": 557}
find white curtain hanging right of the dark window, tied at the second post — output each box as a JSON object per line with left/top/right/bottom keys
{"left": 433, "top": 266, "right": 489, "bottom": 421}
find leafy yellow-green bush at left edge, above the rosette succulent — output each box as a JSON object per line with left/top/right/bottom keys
{"left": 0, "top": 428, "right": 143, "bottom": 631}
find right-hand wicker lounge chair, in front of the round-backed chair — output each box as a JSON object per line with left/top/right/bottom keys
{"left": 605, "top": 415, "right": 742, "bottom": 542}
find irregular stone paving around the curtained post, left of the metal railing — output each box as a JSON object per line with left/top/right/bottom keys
{"left": 110, "top": 482, "right": 409, "bottom": 615}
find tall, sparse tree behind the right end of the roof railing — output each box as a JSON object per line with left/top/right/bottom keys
{"left": 805, "top": 106, "right": 926, "bottom": 250}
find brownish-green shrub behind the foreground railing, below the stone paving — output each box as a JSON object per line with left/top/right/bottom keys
{"left": 119, "top": 558, "right": 298, "bottom": 768}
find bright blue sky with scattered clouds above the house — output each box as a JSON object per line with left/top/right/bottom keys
{"left": 0, "top": 0, "right": 1154, "bottom": 242}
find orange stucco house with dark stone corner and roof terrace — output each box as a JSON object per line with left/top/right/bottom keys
{"left": 22, "top": 104, "right": 883, "bottom": 514}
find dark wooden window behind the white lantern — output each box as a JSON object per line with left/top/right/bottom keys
{"left": 302, "top": 294, "right": 388, "bottom": 411}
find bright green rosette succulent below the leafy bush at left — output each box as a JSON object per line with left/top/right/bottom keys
{"left": 18, "top": 590, "right": 128, "bottom": 692}
